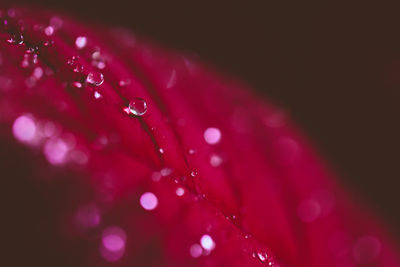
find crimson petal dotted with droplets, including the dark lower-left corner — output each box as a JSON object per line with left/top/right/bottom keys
{"left": 0, "top": 8, "right": 399, "bottom": 266}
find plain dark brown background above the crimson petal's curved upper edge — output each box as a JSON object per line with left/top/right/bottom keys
{"left": 9, "top": 0, "right": 400, "bottom": 237}
